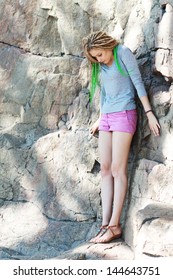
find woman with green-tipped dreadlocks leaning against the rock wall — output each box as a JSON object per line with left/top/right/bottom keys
{"left": 83, "top": 31, "right": 160, "bottom": 243}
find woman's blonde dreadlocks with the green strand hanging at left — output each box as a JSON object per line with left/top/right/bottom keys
{"left": 82, "top": 31, "right": 118, "bottom": 102}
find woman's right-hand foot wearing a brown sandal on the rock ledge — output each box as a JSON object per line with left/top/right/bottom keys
{"left": 94, "top": 225, "right": 122, "bottom": 243}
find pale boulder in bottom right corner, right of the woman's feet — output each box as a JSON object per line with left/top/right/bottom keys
{"left": 135, "top": 204, "right": 173, "bottom": 258}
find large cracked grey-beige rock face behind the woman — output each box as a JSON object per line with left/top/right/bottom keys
{"left": 0, "top": 0, "right": 173, "bottom": 259}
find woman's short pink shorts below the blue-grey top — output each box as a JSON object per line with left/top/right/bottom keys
{"left": 99, "top": 109, "right": 137, "bottom": 134}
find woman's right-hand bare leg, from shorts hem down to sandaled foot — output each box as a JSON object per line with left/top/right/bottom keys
{"left": 96, "top": 132, "right": 133, "bottom": 243}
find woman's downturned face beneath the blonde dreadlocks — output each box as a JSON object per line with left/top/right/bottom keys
{"left": 90, "top": 48, "right": 114, "bottom": 66}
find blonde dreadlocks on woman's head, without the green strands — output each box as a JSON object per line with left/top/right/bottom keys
{"left": 82, "top": 31, "right": 118, "bottom": 63}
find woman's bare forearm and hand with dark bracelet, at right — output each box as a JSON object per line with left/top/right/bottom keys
{"left": 140, "top": 96, "right": 160, "bottom": 136}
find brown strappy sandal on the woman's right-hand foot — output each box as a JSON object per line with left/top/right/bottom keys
{"left": 95, "top": 225, "right": 122, "bottom": 243}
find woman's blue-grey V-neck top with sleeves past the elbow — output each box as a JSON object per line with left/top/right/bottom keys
{"left": 100, "top": 45, "right": 147, "bottom": 114}
